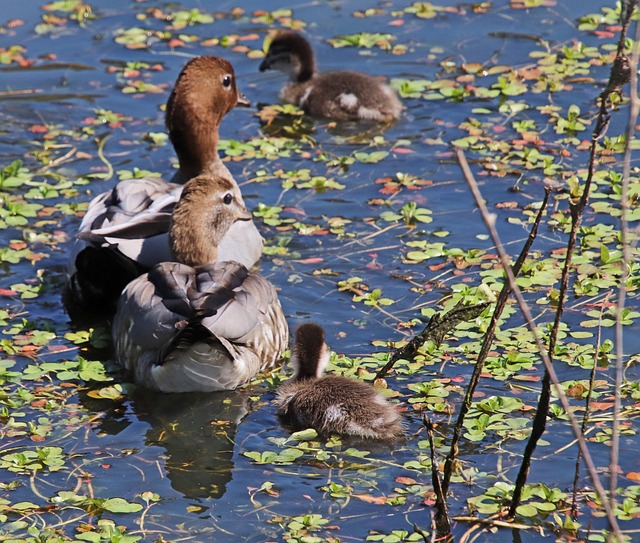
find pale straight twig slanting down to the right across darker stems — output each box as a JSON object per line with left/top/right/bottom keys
{"left": 456, "top": 149, "right": 622, "bottom": 542}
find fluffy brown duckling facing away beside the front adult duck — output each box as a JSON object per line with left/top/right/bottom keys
{"left": 274, "top": 323, "right": 403, "bottom": 440}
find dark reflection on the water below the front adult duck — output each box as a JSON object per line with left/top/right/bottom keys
{"left": 83, "top": 389, "right": 248, "bottom": 499}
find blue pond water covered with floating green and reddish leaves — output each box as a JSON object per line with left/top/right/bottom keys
{"left": 0, "top": 0, "right": 640, "bottom": 542}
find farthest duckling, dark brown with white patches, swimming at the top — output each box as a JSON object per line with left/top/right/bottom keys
{"left": 260, "top": 31, "right": 402, "bottom": 121}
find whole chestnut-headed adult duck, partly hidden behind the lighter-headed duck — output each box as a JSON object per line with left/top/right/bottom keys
{"left": 66, "top": 56, "right": 262, "bottom": 312}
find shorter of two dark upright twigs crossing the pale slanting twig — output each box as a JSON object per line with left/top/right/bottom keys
{"left": 442, "top": 188, "right": 550, "bottom": 495}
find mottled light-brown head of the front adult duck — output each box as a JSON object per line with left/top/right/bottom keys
{"left": 169, "top": 175, "right": 252, "bottom": 266}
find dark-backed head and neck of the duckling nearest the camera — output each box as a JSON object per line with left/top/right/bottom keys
{"left": 291, "top": 323, "right": 331, "bottom": 381}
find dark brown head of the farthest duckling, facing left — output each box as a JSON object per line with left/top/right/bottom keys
{"left": 260, "top": 30, "right": 316, "bottom": 83}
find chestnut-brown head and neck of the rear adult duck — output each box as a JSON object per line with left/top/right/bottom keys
{"left": 165, "top": 56, "right": 250, "bottom": 180}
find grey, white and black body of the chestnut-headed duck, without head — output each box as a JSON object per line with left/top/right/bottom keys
{"left": 67, "top": 178, "right": 263, "bottom": 312}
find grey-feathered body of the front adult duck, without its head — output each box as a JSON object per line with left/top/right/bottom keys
{"left": 113, "top": 262, "right": 288, "bottom": 392}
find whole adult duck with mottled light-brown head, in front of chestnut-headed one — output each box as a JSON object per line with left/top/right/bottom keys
{"left": 112, "top": 174, "right": 289, "bottom": 392}
